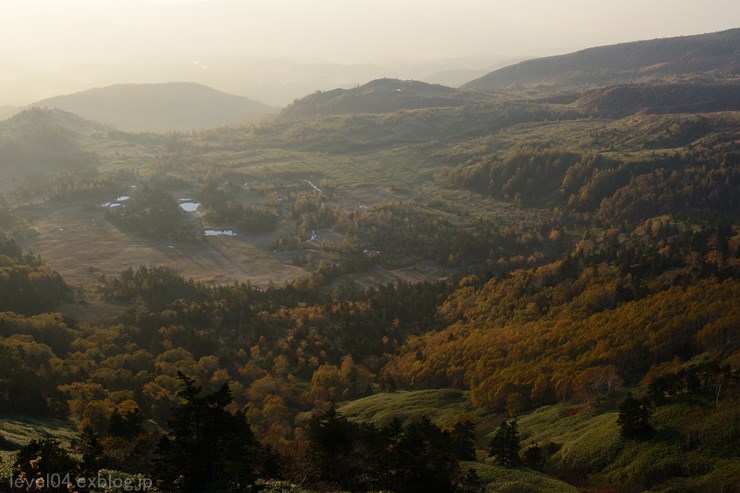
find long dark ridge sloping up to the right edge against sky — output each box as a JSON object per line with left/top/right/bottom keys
{"left": 463, "top": 29, "right": 740, "bottom": 90}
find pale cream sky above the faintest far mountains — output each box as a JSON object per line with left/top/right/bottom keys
{"left": 5, "top": 0, "right": 740, "bottom": 68}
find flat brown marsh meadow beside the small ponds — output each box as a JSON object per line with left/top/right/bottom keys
{"left": 18, "top": 199, "right": 306, "bottom": 286}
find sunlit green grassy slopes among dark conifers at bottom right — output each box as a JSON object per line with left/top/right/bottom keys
{"left": 338, "top": 389, "right": 740, "bottom": 492}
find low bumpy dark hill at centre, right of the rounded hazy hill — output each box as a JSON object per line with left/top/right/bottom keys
{"left": 280, "top": 79, "right": 491, "bottom": 119}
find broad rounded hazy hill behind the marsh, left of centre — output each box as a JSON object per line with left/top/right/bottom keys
{"left": 32, "top": 82, "right": 277, "bottom": 132}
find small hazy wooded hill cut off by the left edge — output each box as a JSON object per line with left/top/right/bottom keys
{"left": 0, "top": 108, "right": 101, "bottom": 177}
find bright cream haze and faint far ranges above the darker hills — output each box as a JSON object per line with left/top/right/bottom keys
{"left": 0, "top": 0, "right": 740, "bottom": 106}
